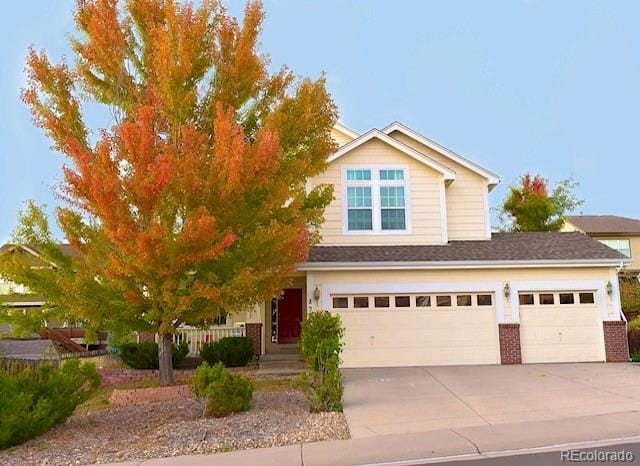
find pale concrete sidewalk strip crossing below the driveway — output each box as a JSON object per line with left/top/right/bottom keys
{"left": 100, "top": 411, "right": 640, "bottom": 466}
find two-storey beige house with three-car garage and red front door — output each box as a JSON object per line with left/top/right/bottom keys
{"left": 242, "top": 123, "right": 630, "bottom": 367}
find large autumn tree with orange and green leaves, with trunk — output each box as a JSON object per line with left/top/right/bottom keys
{"left": 3, "top": 0, "right": 337, "bottom": 384}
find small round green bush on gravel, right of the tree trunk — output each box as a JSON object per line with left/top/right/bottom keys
{"left": 193, "top": 362, "right": 254, "bottom": 417}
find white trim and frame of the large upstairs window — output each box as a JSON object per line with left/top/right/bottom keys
{"left": 341, "top": 164, "right": 411, "bottom": 236}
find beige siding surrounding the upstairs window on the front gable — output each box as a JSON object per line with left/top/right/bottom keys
{"left": 311, "top": 139, "right": 442, "bottom": 245}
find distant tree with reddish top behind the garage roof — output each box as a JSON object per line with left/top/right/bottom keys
{"left": 498, "top": 173, "right": 584, "bottom": 231}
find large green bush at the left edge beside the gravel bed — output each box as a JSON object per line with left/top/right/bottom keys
{"left": 0, "top": 359, "right": 100, "bottom": 449}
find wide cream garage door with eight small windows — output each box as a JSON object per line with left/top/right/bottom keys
{"left": 331, "top": 293, "right": 499, "bottom": 367}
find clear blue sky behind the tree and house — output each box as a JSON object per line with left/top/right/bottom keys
{"left": 0, "top": 0, "right": 640, "bottom": 241}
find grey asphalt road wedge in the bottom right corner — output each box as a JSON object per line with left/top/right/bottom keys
{"left": 418, "top": 443, "right": 640, "bottom": 466}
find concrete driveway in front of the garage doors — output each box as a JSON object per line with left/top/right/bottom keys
{"left": 343, "top": 363, "right": 640, "bottom": 438}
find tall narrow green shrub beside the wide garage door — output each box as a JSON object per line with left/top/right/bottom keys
{"left": 298, "top": 312, "right": 344, "bottom": 411}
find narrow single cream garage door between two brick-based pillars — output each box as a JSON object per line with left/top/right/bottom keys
{"left": 518, "top": 291, "right": 605, "bottom": 363}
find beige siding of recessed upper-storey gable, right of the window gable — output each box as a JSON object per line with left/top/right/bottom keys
{"left": 390, "top": 131, "right": 490, "bottom": 240}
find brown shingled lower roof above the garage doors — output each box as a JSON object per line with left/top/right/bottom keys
{"left": 300, "top": 232, "right": 629, "bottom": 270}
